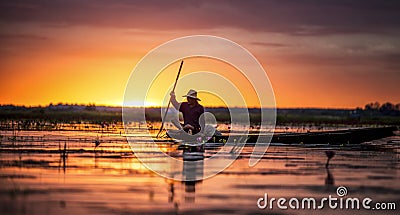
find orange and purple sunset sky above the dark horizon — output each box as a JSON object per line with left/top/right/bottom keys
{"left": 0, "top": 0, "right": 400, "bottom": 108}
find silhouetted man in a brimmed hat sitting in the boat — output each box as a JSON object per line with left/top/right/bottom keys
{"left": 170, "top": 89, "right": 204, "bottom": 134}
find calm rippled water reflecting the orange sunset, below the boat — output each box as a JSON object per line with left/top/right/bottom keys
{"left": 0, "top": 128, "right": 400, "bottom": 215}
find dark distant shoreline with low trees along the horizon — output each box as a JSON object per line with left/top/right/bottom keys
{"left": 0, "top": 102, "right": 400, "bottom": 125}
